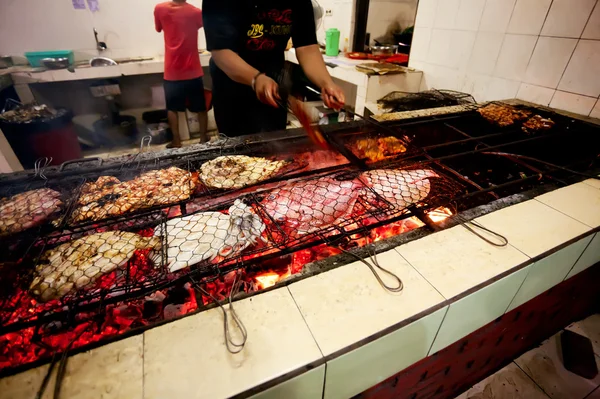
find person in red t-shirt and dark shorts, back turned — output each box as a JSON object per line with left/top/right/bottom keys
{"left": 154, "top": 0, "right": 208, "bottom": 147}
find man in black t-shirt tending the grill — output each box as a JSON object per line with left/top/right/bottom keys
{"left": 202, "top": 0, "right": 345, "bottom": 135}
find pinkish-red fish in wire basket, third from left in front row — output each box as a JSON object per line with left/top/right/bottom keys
{"left": 261, "top": 176, "right": 363, "bottom": 235}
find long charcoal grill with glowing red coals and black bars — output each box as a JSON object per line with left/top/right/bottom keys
{"left": 0, "top": 101, "right": 600, "bottom": 374}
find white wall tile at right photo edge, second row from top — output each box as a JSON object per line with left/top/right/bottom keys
{"left": 558, "top": 40, "right": 600, "bottom": 97}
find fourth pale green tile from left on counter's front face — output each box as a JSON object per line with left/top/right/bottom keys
{"left": 508, "top": 236, "right": 592, "bottom": 311}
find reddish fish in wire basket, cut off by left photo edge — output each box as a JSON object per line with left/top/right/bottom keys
{"left": 0, "top": 188, "right": 63, "bottom": 236}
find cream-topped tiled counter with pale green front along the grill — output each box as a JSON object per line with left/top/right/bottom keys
{"left": 0, "top": 180, "right": 600, "bottom": 399}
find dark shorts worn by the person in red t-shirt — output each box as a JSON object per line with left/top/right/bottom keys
{"left": 165, "top": 77, "right": 206, "bottom": 112}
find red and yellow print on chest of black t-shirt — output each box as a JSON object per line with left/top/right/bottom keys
{"left": 246, "top": 9, "right": 292, "bottom": 51}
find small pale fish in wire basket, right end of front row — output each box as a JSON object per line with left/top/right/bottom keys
{"left": 362, "top": 169, "right": 440, "bottom": 209}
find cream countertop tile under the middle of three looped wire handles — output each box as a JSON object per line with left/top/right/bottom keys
{"left": 289, "top": 250, "right": 444, "bottom": 356}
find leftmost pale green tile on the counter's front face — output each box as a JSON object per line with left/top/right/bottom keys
{"left": 251, "top": 364, "right": 325, "bottom": 399}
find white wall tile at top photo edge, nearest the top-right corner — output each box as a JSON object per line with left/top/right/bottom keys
{"left": 542, "top": 0, "right": 596, "bottom": 38}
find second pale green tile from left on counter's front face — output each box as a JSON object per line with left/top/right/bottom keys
{"left": 324, "top": 307, "right": 447, "bottom": 399}
